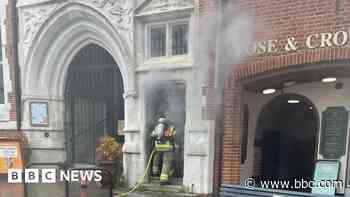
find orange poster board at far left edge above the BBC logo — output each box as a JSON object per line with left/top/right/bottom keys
{"left": 0, "top": 138, "right": 23, "bottom": 174}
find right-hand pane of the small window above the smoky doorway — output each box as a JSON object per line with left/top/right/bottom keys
{"left": 172, "top": 24, "right": 188, "bottom": 55}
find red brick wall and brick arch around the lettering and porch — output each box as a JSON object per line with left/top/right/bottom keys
{"left": 217, "top": 0, "right": 350, "bottom": 188}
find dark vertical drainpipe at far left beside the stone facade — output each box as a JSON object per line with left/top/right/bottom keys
{"left": 8, "top": 0, "right": 22, "bottom": 130}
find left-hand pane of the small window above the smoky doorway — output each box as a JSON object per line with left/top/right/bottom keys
{"left": 151, "top": 27, "right": 166, "bottom": 57}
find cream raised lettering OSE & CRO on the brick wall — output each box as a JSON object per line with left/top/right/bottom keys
{"left": 248, "top": 30, "right": 350, "bottom": 55}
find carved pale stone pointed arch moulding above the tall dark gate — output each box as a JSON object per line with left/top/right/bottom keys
{"left": 22, "top": 3, "right": 135, "bottom": 97}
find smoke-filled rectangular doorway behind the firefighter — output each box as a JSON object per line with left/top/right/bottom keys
{"left": 146, "top": 81, "right": 186, "bottom": 184}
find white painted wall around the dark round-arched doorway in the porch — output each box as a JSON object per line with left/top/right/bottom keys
{"left": 241, "top": 78, "right": 350, "bottom": 192}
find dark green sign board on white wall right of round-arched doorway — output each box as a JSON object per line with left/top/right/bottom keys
{"left": 320, "top": 107, "right": 349, "bottom": 159}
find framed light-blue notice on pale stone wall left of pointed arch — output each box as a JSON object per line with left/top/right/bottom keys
{"left": 29, "top": 102, "right": 49, "bottom": 127}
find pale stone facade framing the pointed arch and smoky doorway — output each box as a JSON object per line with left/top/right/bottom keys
{"left": 17, "top": 0, "right": 214, "bottom": 193}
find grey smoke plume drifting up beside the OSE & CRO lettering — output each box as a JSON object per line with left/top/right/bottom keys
{"left": 197, "top": 1, "right": 254, "bottom": 96}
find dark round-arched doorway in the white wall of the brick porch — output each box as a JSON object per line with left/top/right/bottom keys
{"left": 255, "top": 94, "right": 319, "bottom": 191}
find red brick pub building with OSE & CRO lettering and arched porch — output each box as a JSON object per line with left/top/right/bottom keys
{"left": 216, "top": 0, "right": 350, "bottom": 193}
